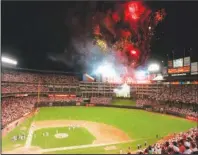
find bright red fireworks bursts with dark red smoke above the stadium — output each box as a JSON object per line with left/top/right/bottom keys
{"left": 92, "top": 1, "right": 166, "bottom": 67}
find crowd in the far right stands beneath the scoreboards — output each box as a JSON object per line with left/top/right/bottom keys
{"left": 149, "top": 84, "right": 198, "bottom": 104}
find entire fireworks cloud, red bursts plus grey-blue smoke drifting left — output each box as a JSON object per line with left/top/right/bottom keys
{"left": 50, "top": 1, "right": 166, "bottom": 74}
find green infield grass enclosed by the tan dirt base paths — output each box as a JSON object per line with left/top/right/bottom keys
{"left": 32, "top": 127, "right": 95, "bottom": 149}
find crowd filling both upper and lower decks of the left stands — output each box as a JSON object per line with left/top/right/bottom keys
{"left": 1, "top": 70, "right": 83, "bottom": 126}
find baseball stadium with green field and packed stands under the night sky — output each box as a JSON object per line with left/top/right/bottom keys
{"left": 2, "top": 59, "right": 198, "bottom": 154}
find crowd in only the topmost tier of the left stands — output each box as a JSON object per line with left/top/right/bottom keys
{"left": 2, "top": 70, "right": 78, "bottom": 84}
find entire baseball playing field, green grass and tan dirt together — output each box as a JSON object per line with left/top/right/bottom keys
{"left": 2, "top": 107, "right": 196, "bottom": 153}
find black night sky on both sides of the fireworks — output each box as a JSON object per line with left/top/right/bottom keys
{"left": 1, "top": 1, "right": 198, "bottom": 71}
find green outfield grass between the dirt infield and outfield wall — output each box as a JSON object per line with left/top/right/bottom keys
{"left": 35, "top": 107, "right": 196, "bottom": 139}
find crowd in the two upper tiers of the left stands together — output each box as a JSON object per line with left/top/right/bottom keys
{"left": 1, "top": 70, "right": 79, "bottom": 94}
